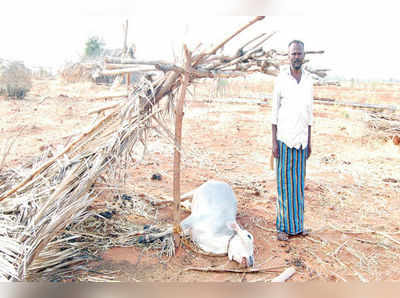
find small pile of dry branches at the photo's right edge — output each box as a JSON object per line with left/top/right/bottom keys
{"left": 366, "top": 111, "right": 400, "bottom": 138}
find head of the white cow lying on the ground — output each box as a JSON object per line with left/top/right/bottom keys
{"left": 227, "top": 222, "right": 254, "bottom": 267}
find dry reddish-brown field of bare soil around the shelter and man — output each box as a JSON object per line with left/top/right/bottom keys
{"left": 0, "top": 79, "right": 400, "bottom": 282}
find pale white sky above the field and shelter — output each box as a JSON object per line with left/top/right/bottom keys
{"left": 0, "top": 0, "right": 400, "bottom": 80}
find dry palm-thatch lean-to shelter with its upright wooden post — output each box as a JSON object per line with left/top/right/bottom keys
{"left": 0, "top": 17, "right": 323, "bottom": 281}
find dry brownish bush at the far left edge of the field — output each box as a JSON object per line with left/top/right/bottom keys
{"left": 0, "top": 59, "right": 32, "bottom": 98}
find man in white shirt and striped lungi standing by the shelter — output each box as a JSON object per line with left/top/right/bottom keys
{"left": 272, "top": 40, "right": 313, "bottom": 241}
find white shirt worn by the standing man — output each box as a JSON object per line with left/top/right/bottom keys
{"left": 271, "top": 66, "right": 313, "bottom": 149}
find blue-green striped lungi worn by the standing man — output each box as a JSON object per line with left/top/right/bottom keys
{"left": 276, "top": 140, "right": 308, "bottom": 235}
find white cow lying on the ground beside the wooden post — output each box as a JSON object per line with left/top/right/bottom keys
{"left": 181, "top": 180, "right": 254, "bottom": 267}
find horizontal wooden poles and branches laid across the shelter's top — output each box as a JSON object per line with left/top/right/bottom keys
{"left": 101, "top": 20, "right": 329, "bottom": 81}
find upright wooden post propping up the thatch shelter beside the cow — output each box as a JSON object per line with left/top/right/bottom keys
{"left": 173, "top": 45, "right": 191, "bottom": 248}
